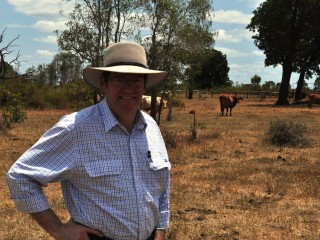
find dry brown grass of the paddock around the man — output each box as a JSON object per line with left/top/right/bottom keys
{"left": 0, "top": 97, "right": 320, "bottom": 240}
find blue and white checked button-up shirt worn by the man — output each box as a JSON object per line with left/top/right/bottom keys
{"left": 7, "top": 99, "right": 170, "bottom": 240}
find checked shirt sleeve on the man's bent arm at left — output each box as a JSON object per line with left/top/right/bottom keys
{"left": 7, "top": 118, "right": 73, "bottom": 213}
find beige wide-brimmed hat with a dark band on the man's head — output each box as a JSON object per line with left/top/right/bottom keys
{"left": 83, "top": 42, "right": 167, "bottom": 89}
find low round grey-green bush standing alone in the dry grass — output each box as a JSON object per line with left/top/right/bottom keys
{"left": 267, "top": 120, "right": 309, "bottom": 147}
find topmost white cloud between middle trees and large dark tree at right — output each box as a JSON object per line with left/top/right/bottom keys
{"left": 213, "top": 10, "right": 253, "bottom": 24}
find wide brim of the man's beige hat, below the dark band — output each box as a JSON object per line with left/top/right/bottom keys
{"left": 83, "top": 65, "right": 167, "bottom": 89}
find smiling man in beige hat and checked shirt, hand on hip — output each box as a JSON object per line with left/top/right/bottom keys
{"left": 7, "top": 43, "right": 170, "bottom": 240}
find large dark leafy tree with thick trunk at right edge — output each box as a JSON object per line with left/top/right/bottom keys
{"left": 247, "top": 0, "right": 320, "bottom": 105}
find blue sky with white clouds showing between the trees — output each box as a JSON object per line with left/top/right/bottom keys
{"left": 0, "top": 0, "right": 313, "bottom": 87}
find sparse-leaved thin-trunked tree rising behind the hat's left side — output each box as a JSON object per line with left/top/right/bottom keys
{"left": 56, "top": 0, "right": 141, "bottom": 102}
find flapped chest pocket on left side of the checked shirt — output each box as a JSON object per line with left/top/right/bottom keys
{"left": 84, "top": 158, "right": 123, "bottom": 177}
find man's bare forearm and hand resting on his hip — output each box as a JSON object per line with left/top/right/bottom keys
{"left": 31, "top": 209, "right": 103, "bottom": 240}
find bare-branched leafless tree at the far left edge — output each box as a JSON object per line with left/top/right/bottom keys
{"left": 0, "top": 28, "right": 21, "bottom": 82}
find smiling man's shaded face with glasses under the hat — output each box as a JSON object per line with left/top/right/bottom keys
{"left": 101, "top": 72, "right": 145, "bottom": 112}
